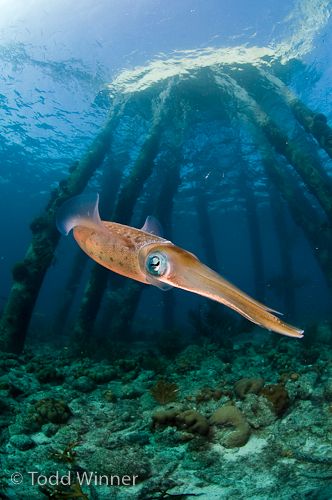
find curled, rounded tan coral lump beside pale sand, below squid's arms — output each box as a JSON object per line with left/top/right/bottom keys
{"left": 209, "top": 405, "right": 251, "bottom": 448}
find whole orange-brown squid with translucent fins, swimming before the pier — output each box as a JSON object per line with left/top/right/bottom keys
{"left": 56, "top": 194, "right": 303, "bottom": 337}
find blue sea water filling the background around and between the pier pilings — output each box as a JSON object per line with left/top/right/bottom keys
{"left": 0, "top": 0, "right": 332, "bottom": 499}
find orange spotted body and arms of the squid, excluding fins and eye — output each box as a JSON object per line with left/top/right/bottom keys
{"left": 74, "top": 221, "right": 303, "bottom": 338}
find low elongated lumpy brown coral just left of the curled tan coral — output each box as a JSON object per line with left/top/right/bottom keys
{"left": 152, "top": 410, "right": 209, "bottom": 436}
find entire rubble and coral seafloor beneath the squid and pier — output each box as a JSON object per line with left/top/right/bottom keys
{"left": 0, "top": 331, "right": 332, "bottom": 500}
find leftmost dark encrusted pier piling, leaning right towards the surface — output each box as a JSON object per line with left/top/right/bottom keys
{"left": 0, "top": 106, "right": 121, "bottom": 353}
